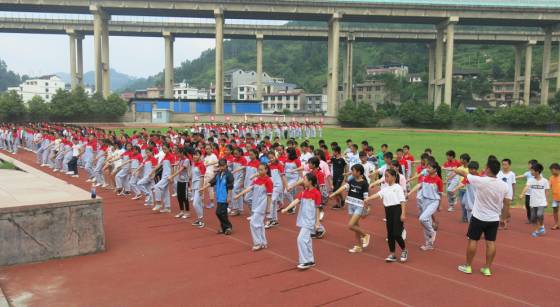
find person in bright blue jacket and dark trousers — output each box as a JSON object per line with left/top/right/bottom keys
{"left": 201, "top": 159, "right": 233, "bottom": 235}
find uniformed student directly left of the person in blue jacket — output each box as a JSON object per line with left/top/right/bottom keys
{"left": 191, "top": 150, "right": 206, "bottom": 228}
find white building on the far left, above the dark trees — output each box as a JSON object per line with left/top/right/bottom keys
{"left": 8, "top": 75, "right": 66, "bottom": 102}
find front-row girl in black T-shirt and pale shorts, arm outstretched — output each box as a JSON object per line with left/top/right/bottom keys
{"left": 329, "top": 164, "right": 371, "bottom": 253}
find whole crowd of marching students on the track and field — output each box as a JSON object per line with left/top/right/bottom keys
{"left": 0, "top": 122, "right": 560, "bottom": 276}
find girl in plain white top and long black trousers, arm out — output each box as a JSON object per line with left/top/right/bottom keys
{"left": 364, "top": 168, "right": 408, "bottom": 262}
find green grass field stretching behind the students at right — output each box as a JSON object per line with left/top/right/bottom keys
{"left": 116, "top": 128, "right": 560, "bottom": 201}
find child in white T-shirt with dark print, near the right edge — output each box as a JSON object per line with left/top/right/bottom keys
{"left": 519, "top": 163, "right": 550, "bottom": 238}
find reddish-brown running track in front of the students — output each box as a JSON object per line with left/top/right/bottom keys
{"left": 0, "top": 152, "right": 560, "bottom": 306}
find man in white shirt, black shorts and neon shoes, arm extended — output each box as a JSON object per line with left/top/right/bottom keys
{"left": 454, "top": 159, "right": 512, "bottom": 276}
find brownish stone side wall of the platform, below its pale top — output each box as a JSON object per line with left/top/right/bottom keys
{"left": 0, "top": 200, "right": 105, "bottom": 265}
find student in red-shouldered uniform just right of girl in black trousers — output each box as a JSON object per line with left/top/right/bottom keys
{"left": 408, "top": 161, "right": 443, "bottom": 251}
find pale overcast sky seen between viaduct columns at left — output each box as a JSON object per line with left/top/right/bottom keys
{"left": 0, "top": 33, "right": 215, "bottom": 77}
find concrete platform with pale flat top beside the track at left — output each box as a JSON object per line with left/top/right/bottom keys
{"left": 0, "top": 153, "right": 105, "bottom": 265}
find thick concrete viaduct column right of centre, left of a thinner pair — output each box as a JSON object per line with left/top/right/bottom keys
{"left": 327, "top": 13, "right": 342, "bottom": 117}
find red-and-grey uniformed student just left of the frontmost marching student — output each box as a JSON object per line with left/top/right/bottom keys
{"left": 235, "top": 164, "right": 273, "bottom": 251}
